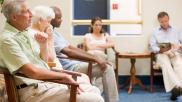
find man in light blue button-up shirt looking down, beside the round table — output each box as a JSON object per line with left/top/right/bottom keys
{"left": 150, "top": 12, "right": 182, "bottom": 100}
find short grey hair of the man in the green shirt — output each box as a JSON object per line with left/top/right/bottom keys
{"left": 2, "top": 0, "right": 26, "bottom": 21}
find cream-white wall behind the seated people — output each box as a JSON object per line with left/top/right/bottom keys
{"left": 0, "top": 0, "right": 182, "bottom": 75}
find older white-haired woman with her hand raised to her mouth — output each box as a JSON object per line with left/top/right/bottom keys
{"left": 29, "top": 6, "right": 62, "bottom": 67}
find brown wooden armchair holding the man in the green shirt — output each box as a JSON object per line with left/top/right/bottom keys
{"left": 0, "top": 67, "right": 81, "bottom": 102}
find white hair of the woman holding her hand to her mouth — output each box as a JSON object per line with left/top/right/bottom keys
{"left": 32, "top": 6, "right": 55, "bottom": 23}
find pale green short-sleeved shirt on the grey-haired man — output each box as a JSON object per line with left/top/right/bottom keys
{"left": 0, "top": 23, "right": 49, "bottom": 85}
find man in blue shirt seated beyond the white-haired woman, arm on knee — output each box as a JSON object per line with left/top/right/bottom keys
{"left": 51, "top": 7, "right": 119, "bottom": 102}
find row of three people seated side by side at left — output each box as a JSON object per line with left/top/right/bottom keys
{"left": 0, "top": 0, "right": 119, "bottom": 102}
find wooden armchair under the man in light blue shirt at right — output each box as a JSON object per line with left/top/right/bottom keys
{"left": 150, "top": 53, "right": 162, "bottom": 92}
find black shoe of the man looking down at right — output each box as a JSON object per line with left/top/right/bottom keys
{"left": 170, "top": 88, "right": 182, "bottom": 101}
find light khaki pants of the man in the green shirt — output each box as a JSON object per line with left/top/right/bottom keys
{"left": 18, "top": 74, "right": 104, "bottom": 102}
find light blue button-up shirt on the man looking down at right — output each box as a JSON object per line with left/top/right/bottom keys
{"left": 150, "top": 26, "right": 182, "bottom": 53}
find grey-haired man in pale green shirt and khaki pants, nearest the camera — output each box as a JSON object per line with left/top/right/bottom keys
{"left": 0, "top": 0, "right": 104, "bottom": 102}
